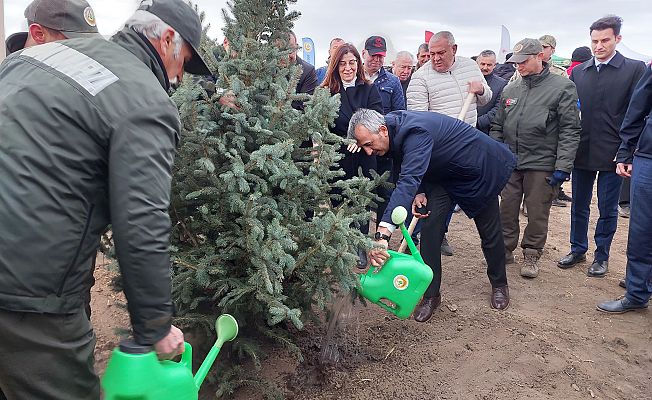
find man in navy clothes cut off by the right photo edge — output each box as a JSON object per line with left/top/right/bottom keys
{"left": 598, "top": 66, "right": 652, "bottom": 313}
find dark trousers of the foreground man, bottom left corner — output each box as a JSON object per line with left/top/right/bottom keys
{"left": 0, "top": 309, "right": 100, "bottom": 400}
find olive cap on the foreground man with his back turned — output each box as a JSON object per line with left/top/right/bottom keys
{"left": 138, "top": 0, "right": 211, "bottom": 75}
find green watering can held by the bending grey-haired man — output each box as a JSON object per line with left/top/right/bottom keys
{"left": 359, "top": 206, "right": 432, "bottom": 319}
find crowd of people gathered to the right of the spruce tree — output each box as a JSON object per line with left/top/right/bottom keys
{"left": 300, "top": 16, "right": 652, "bottom": 322}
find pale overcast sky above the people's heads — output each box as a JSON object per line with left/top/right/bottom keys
{"left": 5, "top": 0, "right": 652, "bottom": 66}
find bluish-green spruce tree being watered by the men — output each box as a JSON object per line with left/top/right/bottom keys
{"left": 170, "top": 0, "right": 378, "bottom": 394}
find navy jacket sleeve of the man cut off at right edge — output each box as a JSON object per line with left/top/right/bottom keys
{"left": 616, "top": 67, "right": 652, "bottom": 164}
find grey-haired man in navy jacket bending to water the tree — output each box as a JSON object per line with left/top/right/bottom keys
{"left": 348, "top": 109, "right": 516, "bottom": 322}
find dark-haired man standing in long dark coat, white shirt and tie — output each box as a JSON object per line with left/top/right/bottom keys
{"left": 557, "top": 15, "right": 645, "bottom": 277}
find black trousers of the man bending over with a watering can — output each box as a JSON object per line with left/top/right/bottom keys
{"left": 421, "top": 185, "right": 507, "bottom": 297}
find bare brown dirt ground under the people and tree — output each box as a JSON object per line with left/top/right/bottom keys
{"left": 93, "top": 192, "right": 652, "bottom": 400}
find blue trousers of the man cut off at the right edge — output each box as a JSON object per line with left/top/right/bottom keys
{"left": 625, "top": 157, "right": 652, "bottom": 304}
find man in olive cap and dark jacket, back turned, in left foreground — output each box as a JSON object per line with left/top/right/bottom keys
{"left": 0, "top": 0, "right": 210, "bottom": 400}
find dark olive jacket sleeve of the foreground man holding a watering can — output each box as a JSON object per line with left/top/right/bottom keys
{"left": 109, "top": 99, "right": 180, "bottom": 345}
